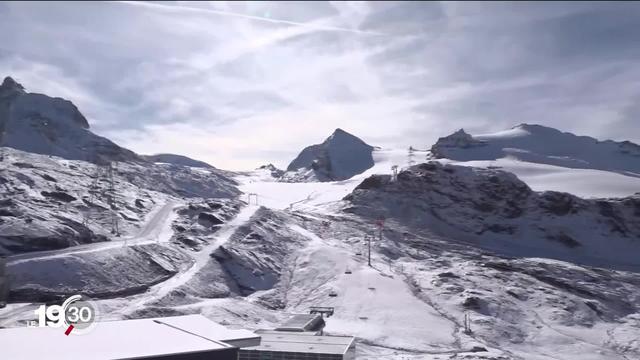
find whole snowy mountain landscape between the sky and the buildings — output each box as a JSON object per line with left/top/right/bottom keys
{"left": 0, "top": 78, "right": 640, "bottom": 360}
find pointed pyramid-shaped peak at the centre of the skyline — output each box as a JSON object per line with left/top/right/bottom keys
{"left": 283, "top": 129, "right": 374, "bottom": 182}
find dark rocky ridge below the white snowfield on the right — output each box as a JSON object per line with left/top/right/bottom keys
{"left": 345, "top": 162, "right": 640, "bottom": 267}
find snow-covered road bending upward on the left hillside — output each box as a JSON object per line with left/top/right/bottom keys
{"left": 8, "top": 201, "right": 180, "bottom": 264}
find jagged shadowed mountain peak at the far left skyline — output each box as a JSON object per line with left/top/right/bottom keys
{"left": 0, "top": 77, "right": 141, "bottom": 162}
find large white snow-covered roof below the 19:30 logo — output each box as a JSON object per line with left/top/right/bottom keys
{"left": 0, "top": 315, "right": 260, "bottom": 360}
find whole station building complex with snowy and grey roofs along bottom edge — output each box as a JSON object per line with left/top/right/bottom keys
{"left": 0, "top": 314, "right": 356, "bottom": 360}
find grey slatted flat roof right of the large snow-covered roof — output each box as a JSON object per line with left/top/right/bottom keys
{"left": 241, "top": 330, "right": 355, "bottom": 355}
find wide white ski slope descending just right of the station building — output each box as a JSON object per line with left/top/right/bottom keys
{"left": 280, "top": 226, "right": 458, "bottom": 353}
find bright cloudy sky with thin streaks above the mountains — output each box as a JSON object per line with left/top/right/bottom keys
{"left": 0, "top": 2, "right": 640, "bottom": 169}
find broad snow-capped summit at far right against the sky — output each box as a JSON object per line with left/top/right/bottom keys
{"left": 431, "top": 124, "right": 640, "bottom": 175}
